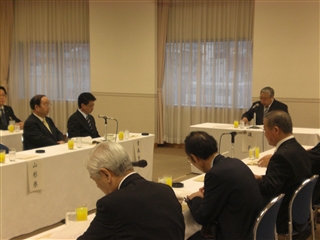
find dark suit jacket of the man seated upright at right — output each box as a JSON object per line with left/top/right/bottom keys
{"left": 258, "top": 138, "right": 311, "bottom": 233}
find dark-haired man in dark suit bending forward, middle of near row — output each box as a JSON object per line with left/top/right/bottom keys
{"left": 184, "top": 131, "right": 263, "bottom": 239}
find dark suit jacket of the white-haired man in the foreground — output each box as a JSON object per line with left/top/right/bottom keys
{"left": 78, "top": 173, "right": 185, "bottom": 240}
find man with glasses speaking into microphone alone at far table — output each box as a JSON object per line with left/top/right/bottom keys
{"left": 241, "top": 87, "right": 288, "bottom": 125}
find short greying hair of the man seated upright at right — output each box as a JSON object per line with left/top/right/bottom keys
{"left": 264, "top": 110, "right": 292, "bottom": 134}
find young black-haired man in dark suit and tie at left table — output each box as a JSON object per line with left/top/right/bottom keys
{"left": 67, "top": 92, "right": 100, "bottom": 138}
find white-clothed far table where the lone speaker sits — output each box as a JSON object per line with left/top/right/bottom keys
{"left": 190, "top": 123, "right": 320, "bottom": 173}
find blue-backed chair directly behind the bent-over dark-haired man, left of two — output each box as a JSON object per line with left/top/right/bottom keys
{"left": 253, "top": 194, "right": 284, "bottom": 240}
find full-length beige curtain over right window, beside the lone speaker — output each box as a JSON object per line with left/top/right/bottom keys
{"left": 163, "top": 0, "right": 254, "bottom": 144}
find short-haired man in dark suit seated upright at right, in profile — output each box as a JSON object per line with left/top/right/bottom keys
{"left": 255, "top": 110, "right": 311, "bottom": 236}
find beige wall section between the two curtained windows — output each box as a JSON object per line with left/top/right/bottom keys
{"left": 89, "top": 0, "right": 156, "bottom": 135}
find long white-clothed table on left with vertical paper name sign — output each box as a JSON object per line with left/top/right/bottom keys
{"left": 0, "top": 133, "right": 154, "bottom": 239}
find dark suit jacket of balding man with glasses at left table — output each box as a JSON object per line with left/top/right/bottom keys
{"left": 23, "top": 113, "right": 64, "bottom": 150}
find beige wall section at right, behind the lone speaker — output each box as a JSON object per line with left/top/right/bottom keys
{"left": 252, "top": 0, "right": 320, "bottom": 127}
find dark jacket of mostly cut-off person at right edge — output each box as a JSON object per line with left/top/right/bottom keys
{"left": 308, "top": 142, "right": 320, "bottom": 204}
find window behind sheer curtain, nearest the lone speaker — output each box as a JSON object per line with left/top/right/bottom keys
{"left": 165, "top": 41, "right": 252, "bottom": 108}
